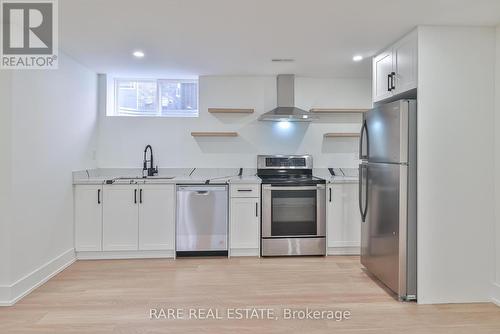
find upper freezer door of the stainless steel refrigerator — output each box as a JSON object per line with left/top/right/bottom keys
{"left": 365, "top": 100, "right": 416, "bottom": 163}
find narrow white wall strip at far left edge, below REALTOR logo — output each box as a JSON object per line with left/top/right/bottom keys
{"left": 0, "top": 71, "right": 12, "bottom": 292}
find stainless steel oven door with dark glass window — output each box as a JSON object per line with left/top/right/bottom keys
{"left": 262, "top": 184, "right": 326, "bottom": 238}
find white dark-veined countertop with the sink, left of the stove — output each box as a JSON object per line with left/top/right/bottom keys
{"left": 73, "top": 168, "right": 261, "bottom": 185}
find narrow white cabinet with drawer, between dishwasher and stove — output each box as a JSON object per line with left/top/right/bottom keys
{"left": 229, "top": 184, "right": 260, "bottom": 256}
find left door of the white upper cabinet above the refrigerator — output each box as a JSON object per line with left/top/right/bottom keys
{"left": 373, "top": 49, "right": 393, "bottom": 102}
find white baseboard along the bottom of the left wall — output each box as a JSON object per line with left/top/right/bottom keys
{"left": 0, "top": 248, "right": 76, "bottom": 306}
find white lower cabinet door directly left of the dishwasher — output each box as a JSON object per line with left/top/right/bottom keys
{"left": 139, "top": 184, "right": 175, "bottom": 250}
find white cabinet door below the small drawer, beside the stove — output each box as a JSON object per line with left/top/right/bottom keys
{"left": 231, "top": 198, "right": 260, "bottom": 249}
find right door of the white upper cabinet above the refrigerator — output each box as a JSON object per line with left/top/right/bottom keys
{"left": 393, "top": 31, "right": 418, "bottom": 94}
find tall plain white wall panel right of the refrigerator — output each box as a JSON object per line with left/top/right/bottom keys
{"left": 418, "top": 27, "right": 495, "bottom": 303}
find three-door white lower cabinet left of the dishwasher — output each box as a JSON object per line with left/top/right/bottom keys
{"left": 74, "top": 184, "right": 175, "bottom": 258}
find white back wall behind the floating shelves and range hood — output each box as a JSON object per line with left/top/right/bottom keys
{"left": 98, "top": 76, "right": 371, "bottom": 168}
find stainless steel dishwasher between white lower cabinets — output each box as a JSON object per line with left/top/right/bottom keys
{"left": 176, "top": 185, "right": 228, "bottom": 257}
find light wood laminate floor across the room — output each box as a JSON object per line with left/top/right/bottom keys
{"left": 0, "top": 256, "right": 500, "bottom": 334}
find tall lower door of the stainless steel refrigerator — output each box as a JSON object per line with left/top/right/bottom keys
{"left": 361, "top": 163, "right": 408, "bottom": 296}
